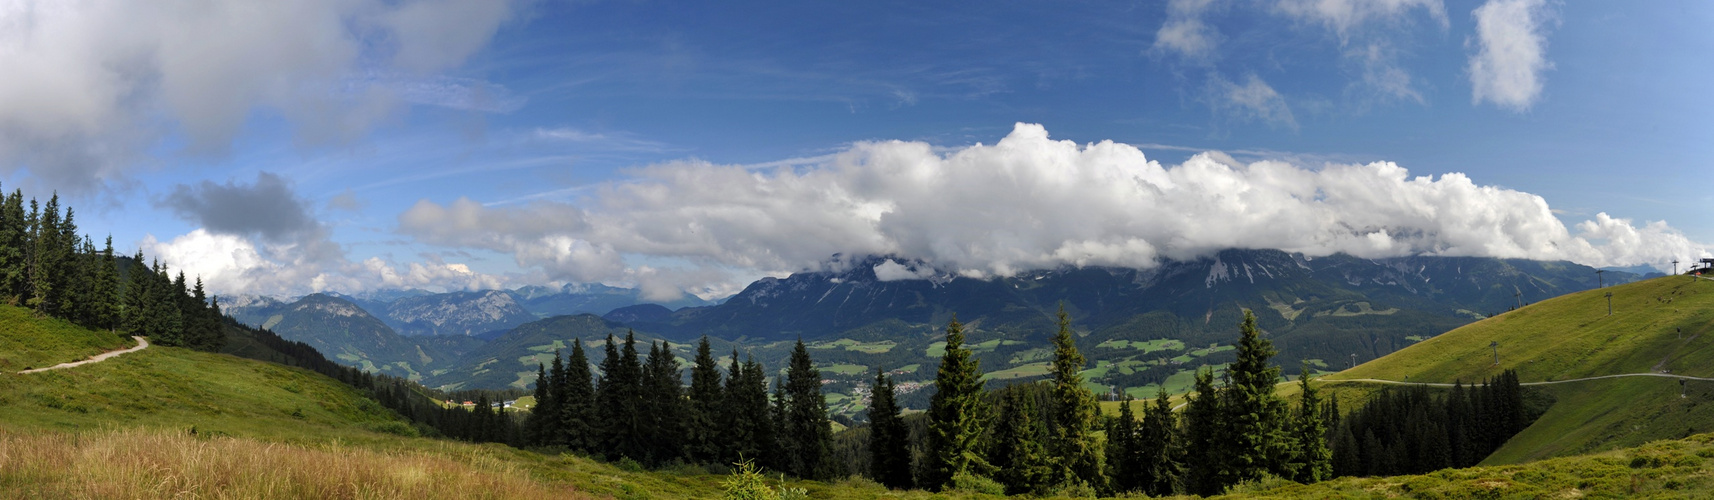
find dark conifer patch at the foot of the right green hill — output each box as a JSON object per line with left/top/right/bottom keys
{"left": 1330, "top": 370, "right": 1534, "bottom": 476}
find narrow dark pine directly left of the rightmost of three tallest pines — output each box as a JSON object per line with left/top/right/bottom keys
{"left": 1183, "top": 370, "right": 1227, "bottom": 497}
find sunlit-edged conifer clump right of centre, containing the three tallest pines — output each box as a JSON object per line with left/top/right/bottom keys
{"left": 857, "top": 312, "right": 1332, "bottom": 495}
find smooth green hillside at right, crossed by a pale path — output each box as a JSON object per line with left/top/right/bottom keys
{"left": 1327, "top": 276, "right": 1714, "bottom": 464}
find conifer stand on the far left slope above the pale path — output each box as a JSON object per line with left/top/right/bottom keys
{"left": 0, "top": 190, "right": 226, "bottom": 351}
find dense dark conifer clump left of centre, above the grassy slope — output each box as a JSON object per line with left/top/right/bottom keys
{"left": 524, "top": 334, "right": 843, "bottom": 479}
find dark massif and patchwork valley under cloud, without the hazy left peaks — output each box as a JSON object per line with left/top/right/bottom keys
{"left": 429, "top": 250, "right": 1635, "bottom": 405}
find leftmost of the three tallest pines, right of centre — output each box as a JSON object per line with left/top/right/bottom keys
{"left": 922, "top": 317, "right": 991, "bottom": 491}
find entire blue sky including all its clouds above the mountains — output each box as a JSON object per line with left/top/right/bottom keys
{"left": 0, "top": 0, "right": 1714, "bottom": 298}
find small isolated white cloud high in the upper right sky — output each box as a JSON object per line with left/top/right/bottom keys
{"left": 1469, "top": 0, "right": 1553, "bottom": 111}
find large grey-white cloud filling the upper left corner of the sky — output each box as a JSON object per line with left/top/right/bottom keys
{"left": 0, "top": 0, "right": 516, "bottom": 192}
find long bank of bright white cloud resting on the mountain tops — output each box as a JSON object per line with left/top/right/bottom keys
{"left": 399, "top": 123, "right": 1709, "bottom": 292}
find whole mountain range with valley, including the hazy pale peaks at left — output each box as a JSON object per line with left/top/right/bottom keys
{"left": 226, "top": 250, "right": 1640, "bottom": 404}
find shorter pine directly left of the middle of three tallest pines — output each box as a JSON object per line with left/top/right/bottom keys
{"left": 989, "top": 390, "right": 1052, "bottom": 495}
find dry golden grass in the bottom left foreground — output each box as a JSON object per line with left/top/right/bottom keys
{"left": 0, "top": 430, "right": 591, "bottom": 498}
